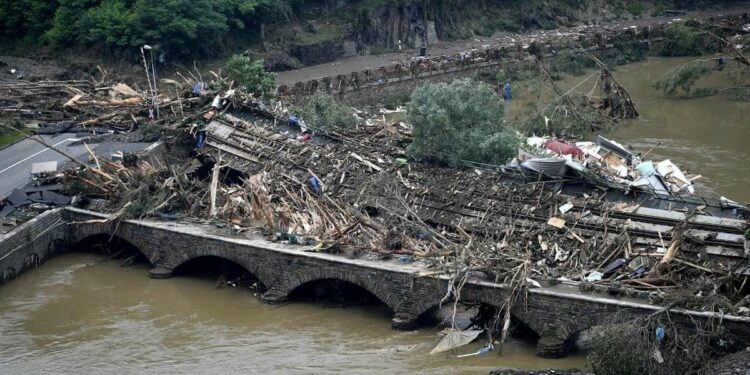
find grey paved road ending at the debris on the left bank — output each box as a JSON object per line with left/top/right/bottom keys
{"left": 0, "top": 134, "right": 150, "bottom": 200}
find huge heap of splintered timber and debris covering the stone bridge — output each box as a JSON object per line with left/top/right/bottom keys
{"left": 50, "top": 88, "right": 750, "bottom": 326}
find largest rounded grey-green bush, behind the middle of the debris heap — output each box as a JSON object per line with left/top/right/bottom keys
{"left": 407, "top": 79, "right": 520, "bottom": 166}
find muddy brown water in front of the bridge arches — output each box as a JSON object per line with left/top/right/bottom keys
{"left": 0, "top": 253, "right": 585, "bottom": 374}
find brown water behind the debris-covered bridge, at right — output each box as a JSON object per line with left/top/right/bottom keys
{"left": 611, "top": 58, "right": 750, "bottom": 202}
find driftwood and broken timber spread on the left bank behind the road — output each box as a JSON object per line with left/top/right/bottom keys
{"left": 0, "top": 72, "right": 209, "bottom": 140}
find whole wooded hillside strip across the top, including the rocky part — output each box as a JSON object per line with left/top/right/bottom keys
{"left": 0, "top": 0, "right": 674, "bottom": 58}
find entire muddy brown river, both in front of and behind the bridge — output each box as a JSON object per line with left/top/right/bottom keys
{"left": 0, "top": 59, "right": 750, "bottom": 374}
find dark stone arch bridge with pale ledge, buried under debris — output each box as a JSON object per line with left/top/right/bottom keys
{"left": 0, "top": 208, "right": 750, "bottom": 357}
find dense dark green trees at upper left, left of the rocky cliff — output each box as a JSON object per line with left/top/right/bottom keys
{"left": 0, "top": 0, "right": 299, "bottom": 56}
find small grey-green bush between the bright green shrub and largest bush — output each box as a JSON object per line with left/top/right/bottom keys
{"left": 293, "top": 92, "right": 358, "bottom": 131}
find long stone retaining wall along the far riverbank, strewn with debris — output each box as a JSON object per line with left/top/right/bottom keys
{"left": 277, "top": 15, "right": 748, "bottom": 105}
